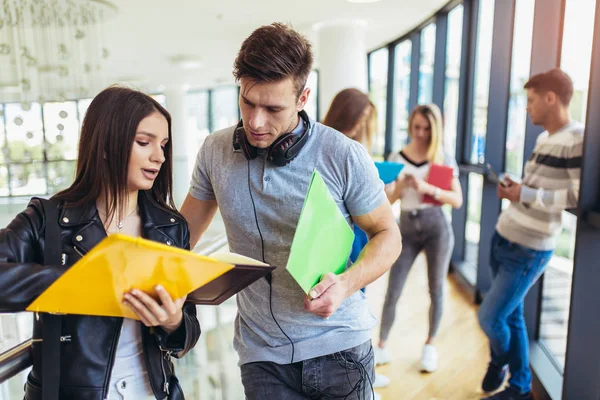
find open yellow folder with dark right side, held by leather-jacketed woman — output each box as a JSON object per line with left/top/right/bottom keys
{"left": 27, "top": 234, "right": 274, "bottom": 319}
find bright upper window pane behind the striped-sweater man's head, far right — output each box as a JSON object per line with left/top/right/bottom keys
{"left": 560, "top": 0, "right": 596, "bottom": 122}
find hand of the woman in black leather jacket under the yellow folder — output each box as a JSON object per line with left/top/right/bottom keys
{"left": 123, "top": 285, "right": 187, "bottom": 333}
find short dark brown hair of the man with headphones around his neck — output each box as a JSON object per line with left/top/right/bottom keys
{"left": 233, "top": 22, "right": 313, "bottom": 96}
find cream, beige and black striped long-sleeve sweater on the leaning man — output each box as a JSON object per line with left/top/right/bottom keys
{"left": 496, "top": 122, "right": 584, "bottom": 250}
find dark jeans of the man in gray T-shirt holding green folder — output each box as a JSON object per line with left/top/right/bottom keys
{"left": 241, "top": 340, "right": 375, "bottom": 400}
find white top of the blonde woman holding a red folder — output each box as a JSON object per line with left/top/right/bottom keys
{"left": 388, "top": 151, "right": 458, "bottom": 211}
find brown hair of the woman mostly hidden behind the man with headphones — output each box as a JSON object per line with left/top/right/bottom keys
{"left": 323, "top": 88, "right": 377, "bottom": 148}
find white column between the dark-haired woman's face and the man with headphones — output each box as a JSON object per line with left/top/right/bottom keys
{"left": 164, "top": 86, "right": 190, "bottom": 207}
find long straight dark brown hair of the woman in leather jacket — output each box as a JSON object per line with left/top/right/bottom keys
{"left": 54, "top": 86, "right": 175, "bottom": 217}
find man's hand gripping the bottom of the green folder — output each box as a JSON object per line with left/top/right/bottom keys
{"left": 304, "top": 273, "right": 349, "bottom": 319}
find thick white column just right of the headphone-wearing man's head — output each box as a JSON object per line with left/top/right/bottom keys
{"left": 314, "top": 20, "right": 367, "bottom": 118}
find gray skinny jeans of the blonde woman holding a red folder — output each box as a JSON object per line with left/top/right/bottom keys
{"left": 379, "top": 207, "right": 454, "bottom": 340}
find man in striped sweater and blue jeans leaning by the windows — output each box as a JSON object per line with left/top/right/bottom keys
{"left": 479, "top": 68, "right": 583, "bottom": 400}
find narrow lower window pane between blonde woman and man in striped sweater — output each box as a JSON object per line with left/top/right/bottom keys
{"left": 463, "top": 173, "right": 483, "bottom": 285}
